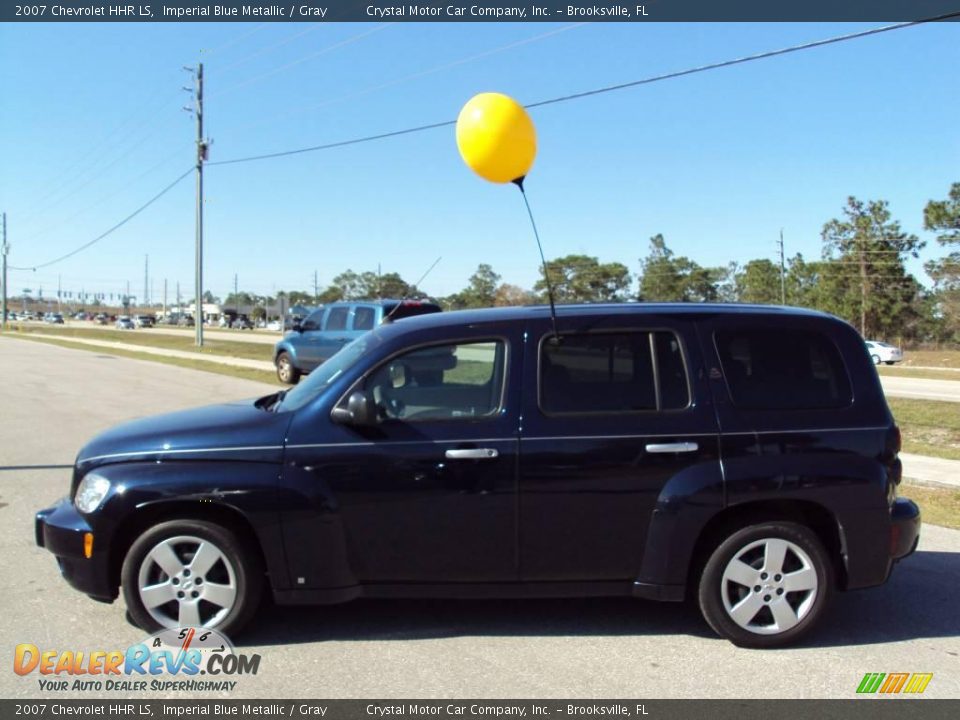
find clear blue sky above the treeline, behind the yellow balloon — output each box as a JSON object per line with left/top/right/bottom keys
{"left": 0, "top": 23, "right": 960, "bottom": 300}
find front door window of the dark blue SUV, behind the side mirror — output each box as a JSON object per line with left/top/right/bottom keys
{"left": 364, "top": 341, "right": 506, "bottom": 421}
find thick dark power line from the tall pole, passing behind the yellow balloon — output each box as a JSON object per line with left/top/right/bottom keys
{"left": 207, "top": 11, "right": 960, "bottom": 165}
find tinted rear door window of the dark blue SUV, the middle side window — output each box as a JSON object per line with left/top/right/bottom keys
{"left": 540, "top": 332, "right": 690, "bottom": 414}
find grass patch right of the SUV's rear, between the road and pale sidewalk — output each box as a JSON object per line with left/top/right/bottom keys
{"left": 887, "top": 397, "right": 960, "bottom": 460}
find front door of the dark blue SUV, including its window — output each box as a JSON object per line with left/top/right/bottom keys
{"left": 288, "top": 331, "right": 520, "bottom": 584}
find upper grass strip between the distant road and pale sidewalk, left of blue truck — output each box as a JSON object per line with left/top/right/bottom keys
{"left": 15, "top": 324, "right": 273, "bottom": 362}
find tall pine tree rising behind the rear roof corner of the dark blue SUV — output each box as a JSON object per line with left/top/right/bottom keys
{"left": 821, "top": 197, "right": 924, "bottom": 337}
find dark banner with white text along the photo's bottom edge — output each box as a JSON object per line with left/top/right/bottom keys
{"left": 0, "top": 697, "right": 960, "bottom": 720}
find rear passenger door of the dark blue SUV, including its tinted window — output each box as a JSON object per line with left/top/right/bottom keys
{"left": 520, "top": 315, "right": 722, "bottom": 581}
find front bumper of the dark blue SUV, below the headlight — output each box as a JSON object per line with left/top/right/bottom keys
{"left": 34, "top": 498, "right": 117, "bottom": 602}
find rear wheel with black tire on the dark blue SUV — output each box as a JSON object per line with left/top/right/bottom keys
{"left": 699, "top": 520, "right": 833, "bottom": 648}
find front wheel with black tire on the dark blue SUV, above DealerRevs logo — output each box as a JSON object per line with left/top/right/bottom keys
{"left": 120, "top": 520, "right": 264, "bottom": 635}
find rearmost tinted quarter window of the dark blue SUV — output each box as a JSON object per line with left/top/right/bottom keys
{"left": 714, "top": 329, "right": 853, "bottom": 410}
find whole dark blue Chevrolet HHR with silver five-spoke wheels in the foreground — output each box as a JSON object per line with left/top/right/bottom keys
{"left": 36, "top": 303, "right": 920, "bottom": 647}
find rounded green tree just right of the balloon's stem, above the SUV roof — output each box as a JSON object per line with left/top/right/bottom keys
{"left": 533, "top": 255, "right": 631, "bottom": 303}
